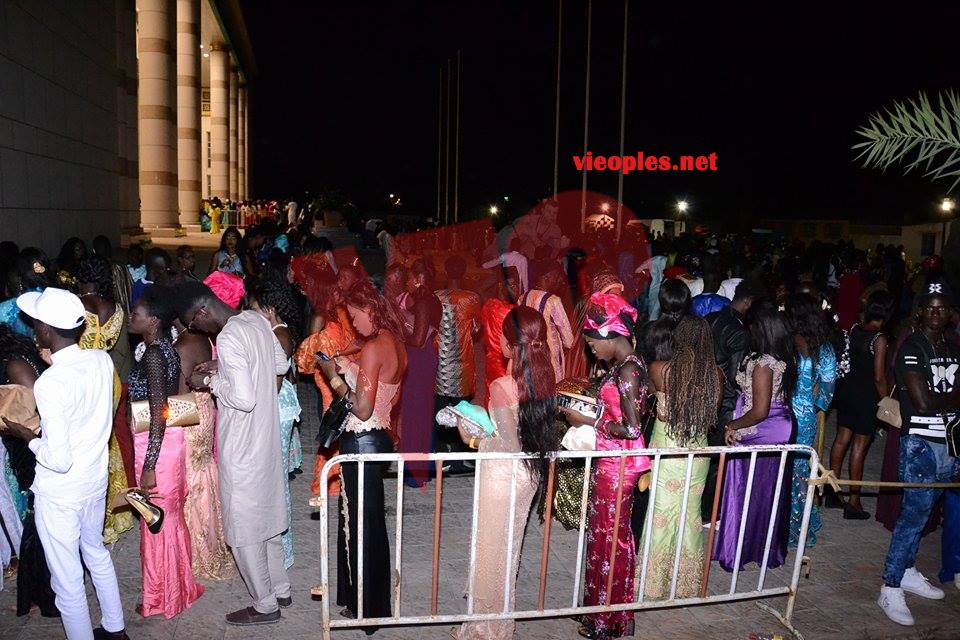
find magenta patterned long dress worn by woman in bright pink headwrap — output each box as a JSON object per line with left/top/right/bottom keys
{"left": 579, "top": 355, "right": 650, "bottom": 638}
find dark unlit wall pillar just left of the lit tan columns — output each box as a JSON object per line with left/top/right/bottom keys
{"left": 114, "top": 0, "right": 141, "bottom": 241}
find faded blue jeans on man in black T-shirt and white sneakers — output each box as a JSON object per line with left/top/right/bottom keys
{"left": 883, "top": 434, "right": 960, "bottom": 587}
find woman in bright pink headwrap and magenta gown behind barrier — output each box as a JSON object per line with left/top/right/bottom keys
{"left": 564, "top": 293, "right": 650, "bottom": 638}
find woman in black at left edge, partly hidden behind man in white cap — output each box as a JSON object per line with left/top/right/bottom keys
{"left": 0, "top": 324, "right": 60, "bottom": 618}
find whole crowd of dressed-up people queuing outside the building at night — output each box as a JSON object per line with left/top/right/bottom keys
{"left": 0, "top": 203, "right": 960, "bottom": 640}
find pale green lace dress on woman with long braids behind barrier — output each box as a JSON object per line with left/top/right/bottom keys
{"left": 637, "top": 391, "right": 710, "bottom": 600}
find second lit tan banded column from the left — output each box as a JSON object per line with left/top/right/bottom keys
{"left": 177, "top": 0, "right": 201, "bottom": 225}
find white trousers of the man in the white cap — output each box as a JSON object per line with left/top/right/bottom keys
{"left": 34, "top": 494, "right": 124, "bottom": 640}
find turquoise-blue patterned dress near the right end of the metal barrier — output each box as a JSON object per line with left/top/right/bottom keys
{"left": 788, "top": 344, "right": 837, "bottom": 547}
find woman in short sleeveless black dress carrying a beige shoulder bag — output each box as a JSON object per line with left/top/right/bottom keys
{"left": 826, "top": 291, "right": 894, "bottom": 520}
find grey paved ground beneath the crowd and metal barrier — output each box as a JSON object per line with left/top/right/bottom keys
{"left": 0, "top": 386, "right": 960, "bottom": 640}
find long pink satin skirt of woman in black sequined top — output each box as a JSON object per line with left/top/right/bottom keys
{"left": 133, "top": 427, "right": 203, "bottom": 619}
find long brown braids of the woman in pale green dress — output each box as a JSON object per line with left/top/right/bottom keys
{"left": 666, "top": 316, "right": 723, "bottom": 447}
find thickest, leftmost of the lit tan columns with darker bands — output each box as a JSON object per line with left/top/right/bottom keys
{"left": 137, "top": 0, "right": 178, "bottom": 231}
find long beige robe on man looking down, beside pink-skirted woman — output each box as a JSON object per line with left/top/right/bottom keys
{"left": 210, "top": 311, "right": 289, "bottom": 547}
